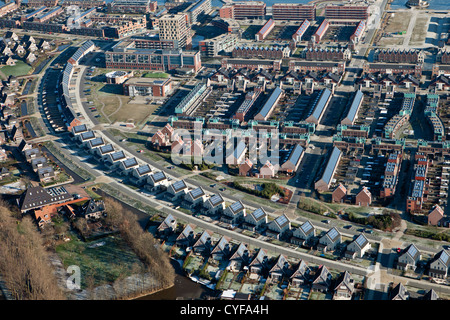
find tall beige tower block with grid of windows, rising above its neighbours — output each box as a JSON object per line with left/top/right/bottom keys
{"left": 158, "top": 14, "right": 192, "bottom": 48}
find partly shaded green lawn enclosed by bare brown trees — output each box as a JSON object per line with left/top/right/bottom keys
{"left": 56, "top": 235, "right": 142, "bottom": 289}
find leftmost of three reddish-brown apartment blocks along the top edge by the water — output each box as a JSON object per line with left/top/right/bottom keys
{"left": 219, "top": 1, "right": 266, "bottom": 20}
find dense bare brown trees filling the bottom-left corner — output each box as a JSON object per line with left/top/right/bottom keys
{"left": 0, "top": 201, "right": 66, "bottom": 300}
